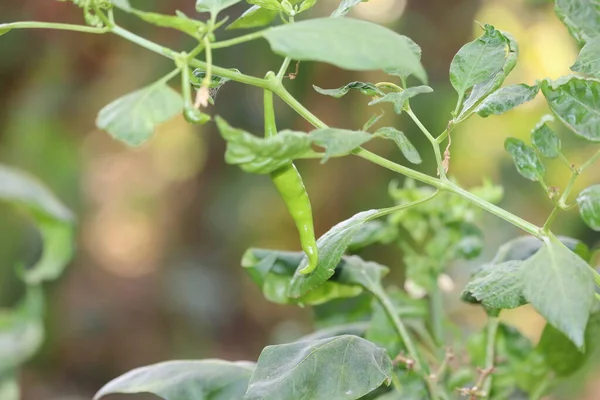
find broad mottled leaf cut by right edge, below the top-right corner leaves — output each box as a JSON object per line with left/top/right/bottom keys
{"left": 542, "top": 76, "right": 600, "bottom": 142}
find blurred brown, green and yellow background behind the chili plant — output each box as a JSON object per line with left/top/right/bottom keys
{"left": 0, "top": 0, "right": 600, "bottom": 400}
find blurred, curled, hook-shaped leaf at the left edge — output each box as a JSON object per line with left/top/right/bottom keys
{"left": 0, "top": 165, "right": 74, "bottom": 284}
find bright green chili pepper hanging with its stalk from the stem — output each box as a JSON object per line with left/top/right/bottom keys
{"left": 264, "top": 83, "right": 319, "bottom": 274}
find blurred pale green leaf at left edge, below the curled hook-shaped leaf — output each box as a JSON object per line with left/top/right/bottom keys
{"left": 0, "top": 286, "right": 44, "bottom": 376}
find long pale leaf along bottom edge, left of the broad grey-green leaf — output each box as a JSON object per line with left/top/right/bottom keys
{"left": 94, "top": 359, "right": 254, "bottom": 400}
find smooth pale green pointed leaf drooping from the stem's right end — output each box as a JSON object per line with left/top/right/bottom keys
{"left": 521, "top": 236, "right": 595, "bottom": 350}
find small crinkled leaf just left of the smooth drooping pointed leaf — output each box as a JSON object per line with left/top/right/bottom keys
{"left": 461, "top": 261, "right": 527, "bottom": 309}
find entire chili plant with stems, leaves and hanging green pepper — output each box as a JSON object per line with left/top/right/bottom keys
{"left": 0, "top": 0, "right": 600, "bottom": 400}
